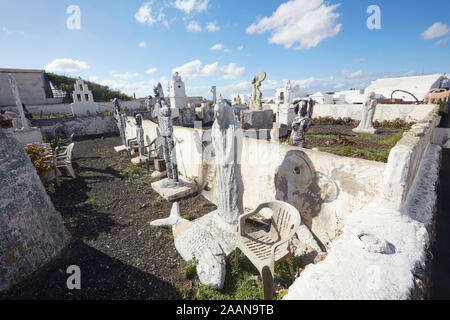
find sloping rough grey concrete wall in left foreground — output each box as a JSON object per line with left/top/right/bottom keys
{"left": 0, "top": 133, "right": 70, "bottom": 291}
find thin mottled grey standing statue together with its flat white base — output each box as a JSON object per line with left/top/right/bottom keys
{"left": 152, "top": 98, "right": 197, "bottom": 201}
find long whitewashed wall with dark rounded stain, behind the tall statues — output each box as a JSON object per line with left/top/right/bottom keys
{"left": 126, "top": 117, "right": 386, "bottom": 244}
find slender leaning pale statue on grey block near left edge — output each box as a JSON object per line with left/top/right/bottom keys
{"left": 5, "top": 73, "right": 43, "bottom": 146}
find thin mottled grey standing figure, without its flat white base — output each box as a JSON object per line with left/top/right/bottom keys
{"left": 158, "top": 98, "right": 178, "bottom": 183}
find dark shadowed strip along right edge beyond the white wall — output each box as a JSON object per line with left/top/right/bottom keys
{"left": 430, "top": 149, "right": 450, "bottom": 300}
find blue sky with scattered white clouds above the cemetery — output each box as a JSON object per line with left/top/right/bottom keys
{"left": 0, "top": 0, "right": 450, "bottom": 97}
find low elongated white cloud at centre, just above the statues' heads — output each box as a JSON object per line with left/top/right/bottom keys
{"left": 172, "top": 60, "right": 245, "bottom": 80}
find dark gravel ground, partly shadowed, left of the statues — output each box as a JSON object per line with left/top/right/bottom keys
{"left": 0, "top": 137, "right": 216, "bottom": 300}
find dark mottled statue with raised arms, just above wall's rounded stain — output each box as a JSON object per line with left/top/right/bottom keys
{"left": 289, "top": 99, "right": 314, "bottom": 148}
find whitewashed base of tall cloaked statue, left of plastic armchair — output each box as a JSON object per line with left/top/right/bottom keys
{"left": 195, "top": 210, "right": 238, "bottom": 256}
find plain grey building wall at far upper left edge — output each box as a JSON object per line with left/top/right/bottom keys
{"left": 0, "top": 71, "right": 47, "bottom": 106}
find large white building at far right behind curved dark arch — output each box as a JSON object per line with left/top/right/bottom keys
{"left": 365, "top": 74, "right": 446, "bottom": 102}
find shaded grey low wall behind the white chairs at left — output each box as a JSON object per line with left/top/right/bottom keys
{"left": 31, "top": 115, "right": 119, "bottom": 140}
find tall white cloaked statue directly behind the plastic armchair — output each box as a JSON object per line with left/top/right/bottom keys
{"left": 211, "top": 101, "right": 243, "bottom": 227}
